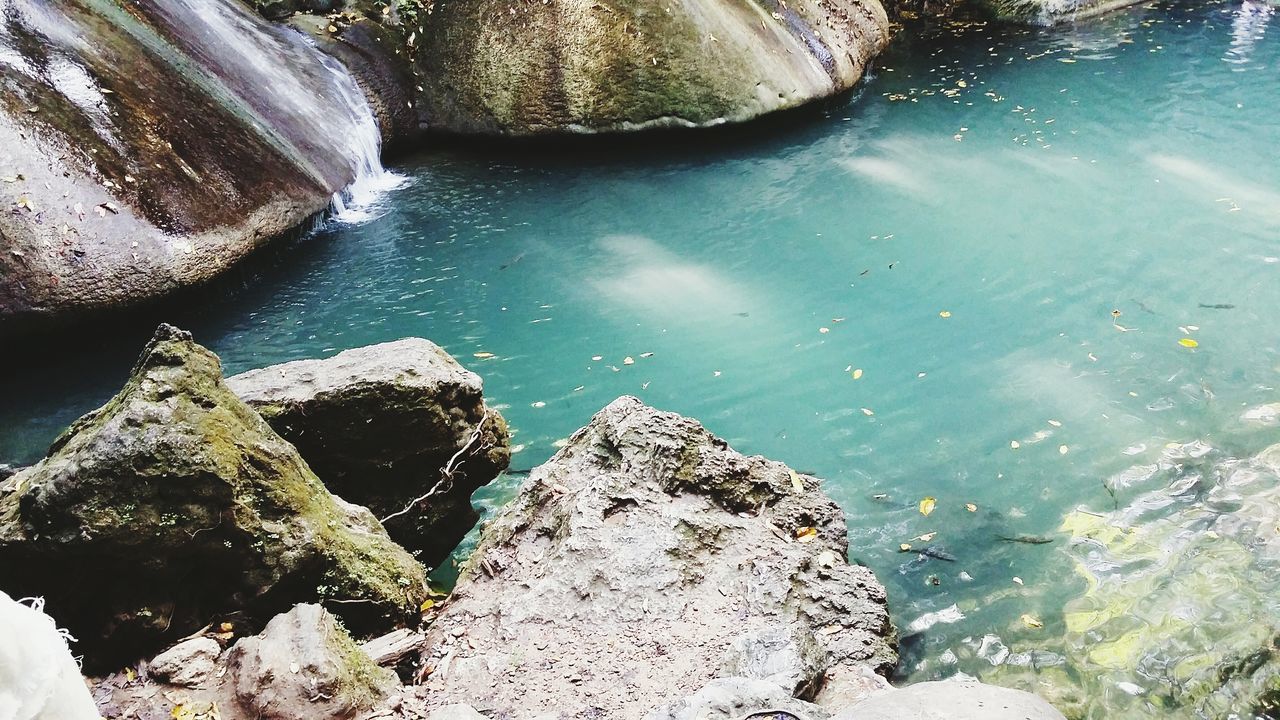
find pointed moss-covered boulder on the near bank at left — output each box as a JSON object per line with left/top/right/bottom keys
{"left": 0, "top": 325, "right": 426, "bottom": 666}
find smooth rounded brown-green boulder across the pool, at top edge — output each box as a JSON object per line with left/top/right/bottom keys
{"left": 416, "top": 0, "right": 888, "bottom": 136}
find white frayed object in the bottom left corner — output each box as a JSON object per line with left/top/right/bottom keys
{"left": 0, "top": 592, "right": 100, "bottom": 720}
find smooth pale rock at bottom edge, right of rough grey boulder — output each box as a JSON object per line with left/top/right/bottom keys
{"left": 832, "top": 680, "right": 1065, "bottom": 720}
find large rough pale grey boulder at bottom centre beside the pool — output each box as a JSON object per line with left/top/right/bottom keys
{"left": 417, "top": 397, "right": 897, "bottom": 719}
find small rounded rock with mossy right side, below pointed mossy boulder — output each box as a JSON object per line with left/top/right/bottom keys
{"left": 228, "top": 605, "right": 399, "bottom": 720}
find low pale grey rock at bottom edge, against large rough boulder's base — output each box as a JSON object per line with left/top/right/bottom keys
{"left": 645, "top": 678, "right": 831, "bottom": 720}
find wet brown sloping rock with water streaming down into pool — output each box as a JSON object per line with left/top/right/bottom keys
{"left": 0, "top": 0, "right": 381, "bottom": 333}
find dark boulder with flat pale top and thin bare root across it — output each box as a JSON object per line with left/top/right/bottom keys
{"left": 227, "top": 338, "right": 511, "bottom": 564}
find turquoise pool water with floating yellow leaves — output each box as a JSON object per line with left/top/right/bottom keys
{"left": 0, "top": 3, "right": 1280, "bottom": 712}
